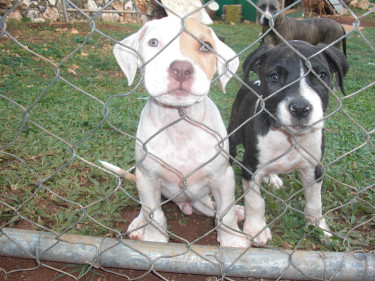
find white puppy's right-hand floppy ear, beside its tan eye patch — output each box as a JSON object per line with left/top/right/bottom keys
{"left": 210, "top": 28, "right": 240, "bottom": 93}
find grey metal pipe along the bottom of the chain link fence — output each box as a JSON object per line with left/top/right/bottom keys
{"left": 0, "top": 228, "right": 375, "bottom": 281}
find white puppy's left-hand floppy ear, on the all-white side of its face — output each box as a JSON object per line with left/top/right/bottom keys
{"left": 113, "top": 25, "right": 147, "bottom": 86}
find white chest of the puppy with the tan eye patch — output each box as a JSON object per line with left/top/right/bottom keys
{"left": 136, "top": 98, "right": 228, "bottom": 182}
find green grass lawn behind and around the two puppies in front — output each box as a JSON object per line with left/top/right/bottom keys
{"left": 0, "top": 16, "right": 375, "bottom": 254}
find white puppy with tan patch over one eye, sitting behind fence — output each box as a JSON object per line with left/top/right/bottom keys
{"left": 103, "top": 16, "right": 250, "bottom": 247}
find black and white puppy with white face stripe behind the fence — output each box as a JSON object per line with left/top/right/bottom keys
{"left": 228, "top": 41, "right": 349, "bottom": 244}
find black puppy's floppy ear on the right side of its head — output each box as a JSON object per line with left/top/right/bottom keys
{"left": 316, "top": 43, "right": 349, "bottom": 95}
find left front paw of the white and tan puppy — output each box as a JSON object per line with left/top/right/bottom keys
{"left": 128, "top": 215, "right": 168, "bottom": 243}
